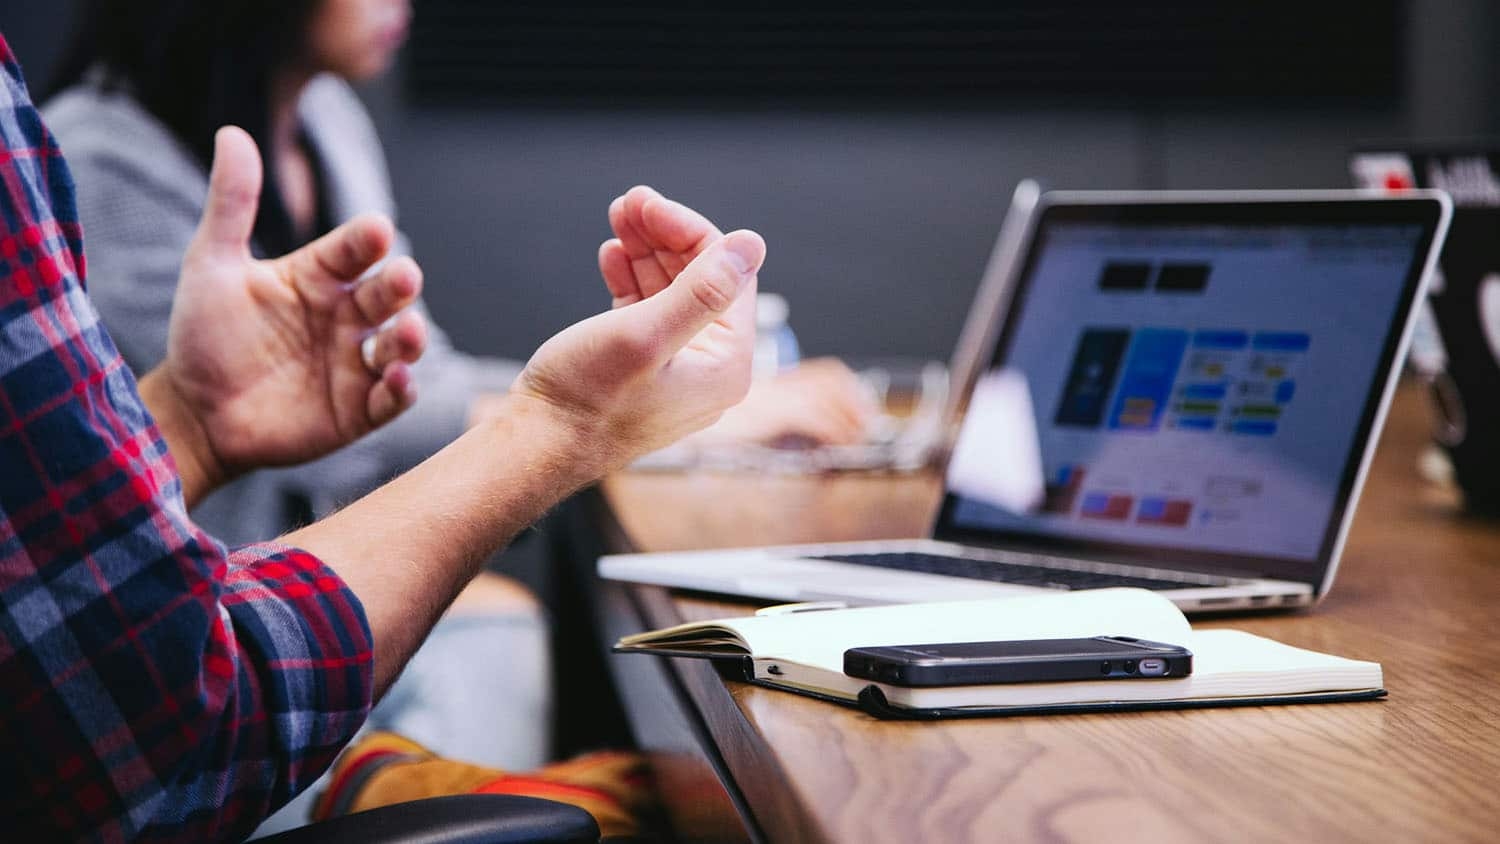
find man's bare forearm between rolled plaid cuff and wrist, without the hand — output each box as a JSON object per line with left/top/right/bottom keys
{"left": 285, "top": 397, "right": 606, "bottom": 694}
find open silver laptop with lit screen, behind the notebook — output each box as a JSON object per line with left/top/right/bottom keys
{"left": 599, "top": 190, "right": 1451, "bottom": 612}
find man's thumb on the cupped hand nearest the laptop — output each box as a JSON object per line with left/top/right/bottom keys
{"left": 633, "top": 229, "right": 765, "bottom": 357}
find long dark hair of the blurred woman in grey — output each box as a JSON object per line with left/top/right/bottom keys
{"left": 47, "top": 0, "right": 321, "bottom": 255}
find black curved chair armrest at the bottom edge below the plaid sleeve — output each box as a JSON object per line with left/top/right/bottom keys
{"left": 257, "top": 795, "right": 599, "bottom": 844}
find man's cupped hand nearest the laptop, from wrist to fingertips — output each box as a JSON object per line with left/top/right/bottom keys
{"left": 512, "top": 187, "right": 765, "bottom": 477}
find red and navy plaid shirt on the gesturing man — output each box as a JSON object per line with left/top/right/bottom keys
{"left": 0, "top": 37, "right": 372, "bottom": 841}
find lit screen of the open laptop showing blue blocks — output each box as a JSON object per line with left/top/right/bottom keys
{"left": 938, "top": 201, "right": 1439, "bottom": 580}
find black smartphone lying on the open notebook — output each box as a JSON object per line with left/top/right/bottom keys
{"left": 845, "top": 636, "right": 1193, "bottom": 687}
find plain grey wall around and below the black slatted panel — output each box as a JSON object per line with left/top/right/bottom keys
{"left": 0, "top": 0, "right": 1500, "bottom": 358}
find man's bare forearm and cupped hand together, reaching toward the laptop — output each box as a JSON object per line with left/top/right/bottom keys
{"left": 287, "top": 189, "right": 765, "bottom": 690}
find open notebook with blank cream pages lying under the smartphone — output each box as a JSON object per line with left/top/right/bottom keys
{"left": 615, "top": 589, "right": 1386, "bottom": 718}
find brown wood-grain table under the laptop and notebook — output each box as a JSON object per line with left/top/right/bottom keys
{"left": 585, "top": 385, "right": 1500, "bottom": 843}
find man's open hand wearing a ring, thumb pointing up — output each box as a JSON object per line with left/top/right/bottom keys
{"left": 141, "top": 127, "right": 426, "bottom": 501}
